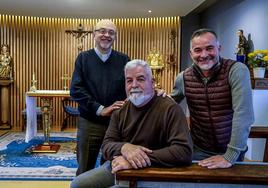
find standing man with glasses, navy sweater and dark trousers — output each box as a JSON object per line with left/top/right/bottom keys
{"left": 70, "top": 20, "right": 129, "bottom": 175}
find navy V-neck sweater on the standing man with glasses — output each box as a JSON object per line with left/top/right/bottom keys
{"left": 70, "top": 49, "right": 129, "bottom": 124}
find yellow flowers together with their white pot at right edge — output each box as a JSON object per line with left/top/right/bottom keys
{"left": 248, "top": 50, "right": 268, "bottom": 78}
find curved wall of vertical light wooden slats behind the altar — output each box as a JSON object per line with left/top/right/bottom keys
{"left": 0, "top": 15, "right": 180, "bottom": 130}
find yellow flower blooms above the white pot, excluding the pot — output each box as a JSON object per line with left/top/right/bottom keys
{"left": 248, "top": 50, "right": 268, "bottom": 68}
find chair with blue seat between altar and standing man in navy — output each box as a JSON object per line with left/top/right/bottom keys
{"left": 61, "top": 98, "right": 80, "bottom": 131}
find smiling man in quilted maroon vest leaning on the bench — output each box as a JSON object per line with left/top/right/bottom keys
{"left": 171, "top": 29, "right": 254, "bottom": 169}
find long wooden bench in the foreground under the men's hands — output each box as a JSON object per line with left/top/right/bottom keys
{"left": 116, "top": 162, "right": 268, "bottom": 188}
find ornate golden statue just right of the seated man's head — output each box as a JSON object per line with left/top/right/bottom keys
{"left": 147, "top": 48, "right": 164, "bottom": 88}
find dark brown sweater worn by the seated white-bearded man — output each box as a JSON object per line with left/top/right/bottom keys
{"left": 103, "top": 96, "right": 192, "bottom": 166}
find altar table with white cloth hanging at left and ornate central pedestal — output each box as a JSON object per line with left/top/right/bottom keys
{"left": 25, "top": 90, "right": 70, "bottom": 153}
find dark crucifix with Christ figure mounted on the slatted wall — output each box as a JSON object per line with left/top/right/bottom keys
{"left": 65, "top": 23, "right": 93, "bottom": 52}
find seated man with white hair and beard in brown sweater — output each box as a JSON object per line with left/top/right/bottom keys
{"left": 71, "top": 59, "right": 193, "bottom": 188}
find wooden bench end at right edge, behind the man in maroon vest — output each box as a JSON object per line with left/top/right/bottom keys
{"left": 249, "top": 126, "right": 268, "bottom": 162}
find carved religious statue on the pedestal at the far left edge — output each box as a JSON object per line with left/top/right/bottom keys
{"left": 0, "top": 44, "right": 13, "bottom": 80}
